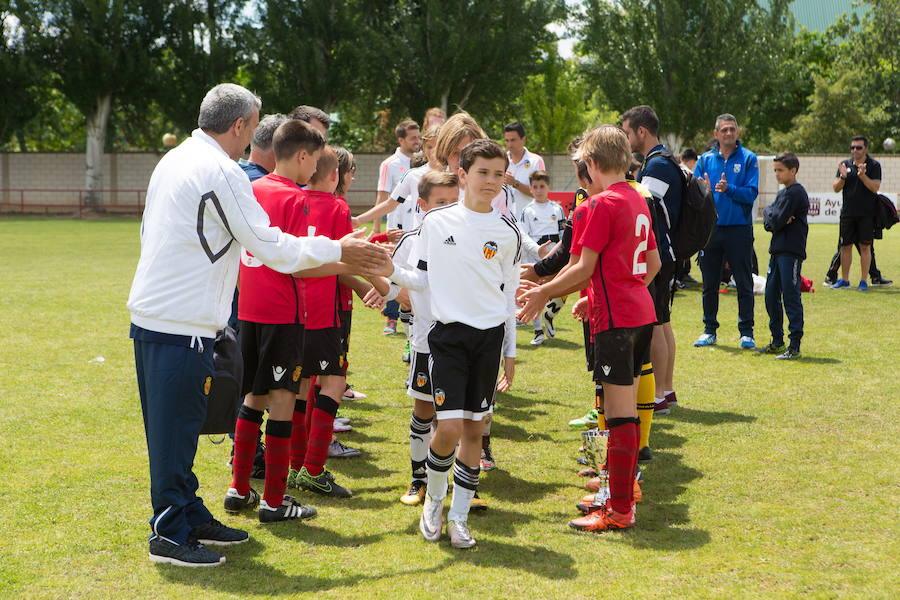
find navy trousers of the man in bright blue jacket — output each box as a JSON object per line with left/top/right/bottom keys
{"left": 700, "top": 225, "right": 754, "bottom": 337}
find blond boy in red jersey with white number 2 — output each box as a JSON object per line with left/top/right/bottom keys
{"left": 518, "top": 125, "right": 660, "bottom": 531}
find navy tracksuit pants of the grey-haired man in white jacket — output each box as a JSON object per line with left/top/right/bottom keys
{"left": 132, "top": 326, "right": 215, "bottom": 544}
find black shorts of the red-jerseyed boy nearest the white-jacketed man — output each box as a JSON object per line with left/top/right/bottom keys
{"left": 241, "top": 321, "right": 304, "bottom": 396}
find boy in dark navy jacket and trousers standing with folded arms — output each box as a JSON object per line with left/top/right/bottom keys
{"left": 763, "top": 152, "right": 809, "bottom": 360}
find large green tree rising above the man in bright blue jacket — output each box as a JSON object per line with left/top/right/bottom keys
{"left": 577, "top": 0, "right": 802, "bottom": 150}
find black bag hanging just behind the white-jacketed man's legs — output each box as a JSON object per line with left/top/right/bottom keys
{"left": 200, "top": 326, "right": 244, "bottom": 435}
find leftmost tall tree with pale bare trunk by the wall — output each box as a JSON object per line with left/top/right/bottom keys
{"left": 13, "top": 0, "right": 167, "bottom": 204}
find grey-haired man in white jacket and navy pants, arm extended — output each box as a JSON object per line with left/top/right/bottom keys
{"left": 128, "top": 84, "right": 390, "bottom": 566}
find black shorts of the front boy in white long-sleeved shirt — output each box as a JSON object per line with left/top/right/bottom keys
{"left": 428, "top": 322, "right": 505, "bottom": 421}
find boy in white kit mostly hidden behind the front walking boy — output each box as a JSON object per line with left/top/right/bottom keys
{"left": 365, "top": 171, "right": 459, "bottom": 506}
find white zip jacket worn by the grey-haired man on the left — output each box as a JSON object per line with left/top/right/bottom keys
{"left": 128, "top": 129, "right": 341, "bottom": 337}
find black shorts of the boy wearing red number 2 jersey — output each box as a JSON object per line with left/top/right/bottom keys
{"left": 594, "top": 325, "right": 653, "bottom": 385}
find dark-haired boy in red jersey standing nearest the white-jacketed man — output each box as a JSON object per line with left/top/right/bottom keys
{"left": 225, "top": 121, "right": 325, "bottom": 523}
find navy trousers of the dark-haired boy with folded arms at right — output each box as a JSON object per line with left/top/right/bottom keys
{"left": 766, "top": 254, "right": 803, "bottom": 350}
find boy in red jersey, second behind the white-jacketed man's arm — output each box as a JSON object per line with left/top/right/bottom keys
{"left": 290, "top": 146, "right": 353, "bottom": 498}
